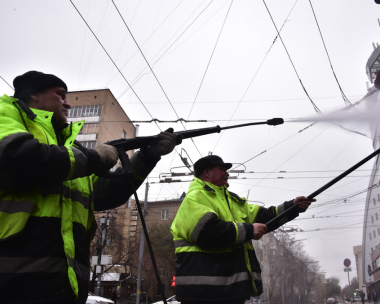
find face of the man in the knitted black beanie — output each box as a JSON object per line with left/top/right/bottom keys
{"left": 30, "top": 87, "right": 71, "bottom": 126}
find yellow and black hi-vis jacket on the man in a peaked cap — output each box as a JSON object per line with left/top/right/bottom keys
{"left": 171, "top": 178, "right": 298, "bottom": 302}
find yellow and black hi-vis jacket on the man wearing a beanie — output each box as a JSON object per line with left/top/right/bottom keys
{"left": 0, "top": 95, "right": 158, "bottom": 304}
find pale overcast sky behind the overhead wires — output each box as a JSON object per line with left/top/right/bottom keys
{"left": 0, "top": 0, "right": 380, "bottom": 286}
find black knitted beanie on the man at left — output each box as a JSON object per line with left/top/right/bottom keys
{"left": 13, "top": 71, "right": 67, "bottom": 100}
